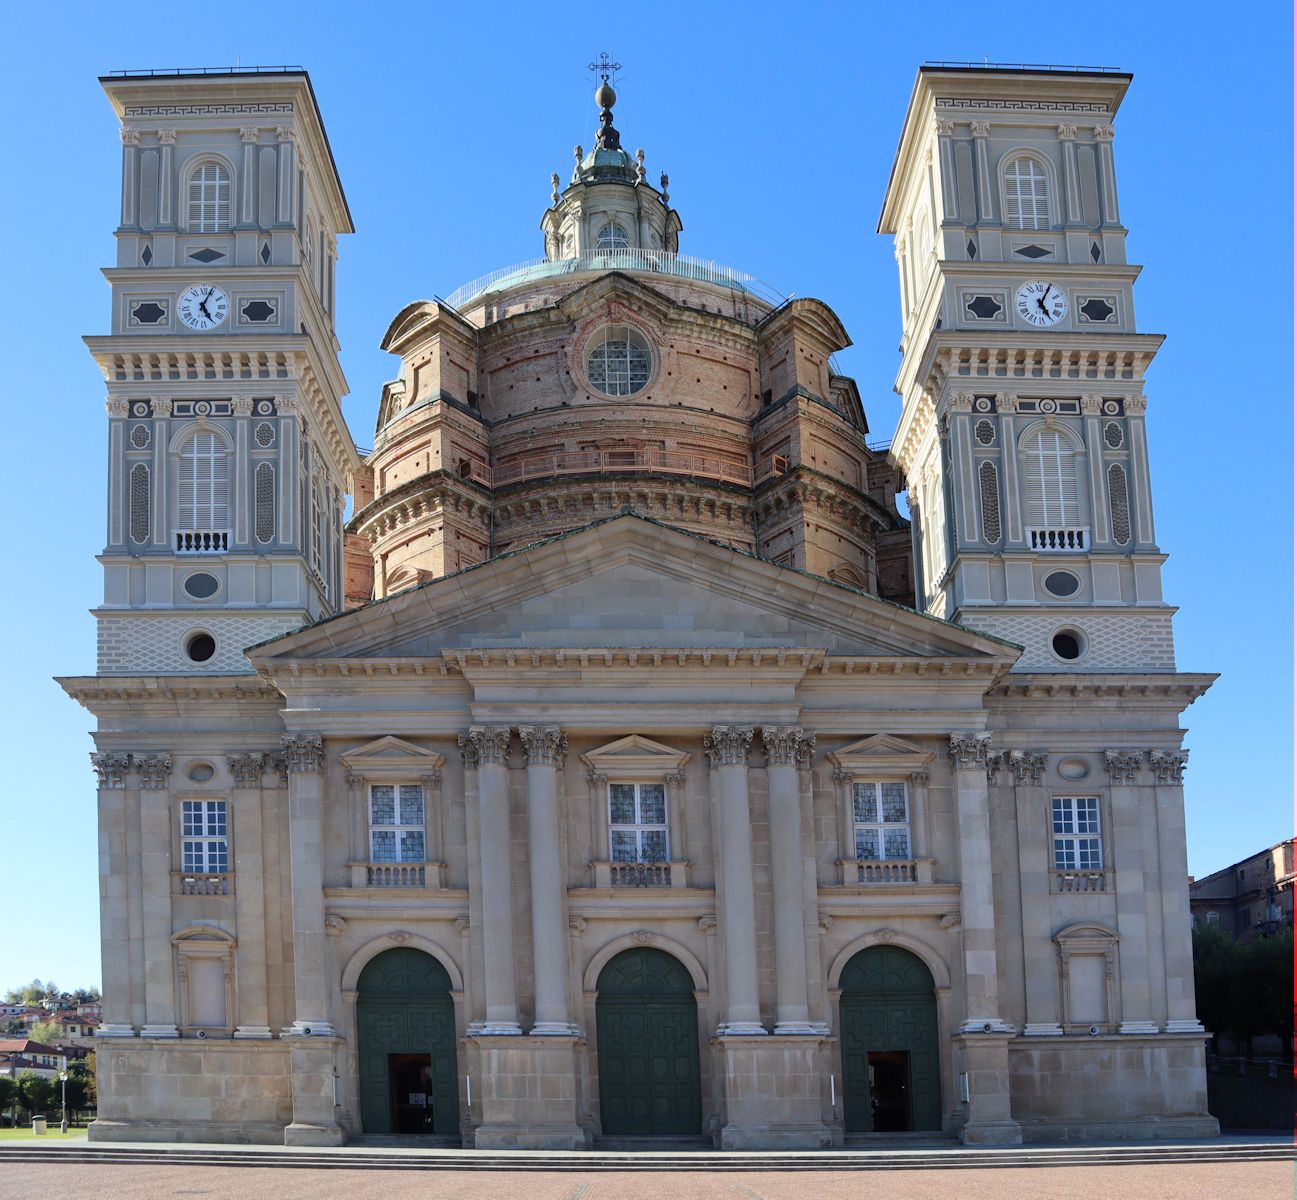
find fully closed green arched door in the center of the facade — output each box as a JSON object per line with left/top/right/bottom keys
{"left": 594, "top": 950, "right": 703, "bottom": 1138}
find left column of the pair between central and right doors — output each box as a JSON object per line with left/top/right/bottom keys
{"left": 703, "top": 725, "right": 765, "bottom": 1035}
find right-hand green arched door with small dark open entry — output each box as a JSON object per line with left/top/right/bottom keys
{"left": 839, "top": 946, "right": 942, "bottom": 1134}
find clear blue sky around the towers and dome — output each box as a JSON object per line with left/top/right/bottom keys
{"left": 0, "top": 0, "right": 1293, "bottom": 989}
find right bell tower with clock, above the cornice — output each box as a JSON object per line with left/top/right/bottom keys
{"left": 878, "top": 65, "right": 1175, "bottom": 672}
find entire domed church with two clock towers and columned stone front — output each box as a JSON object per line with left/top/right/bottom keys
{"left": 61, "top": 60, "right": 1217, "bottom": 1149}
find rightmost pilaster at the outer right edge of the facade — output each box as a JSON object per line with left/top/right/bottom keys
{"left": 1148, "top": 750, "right": 1202, "bottom": 1034}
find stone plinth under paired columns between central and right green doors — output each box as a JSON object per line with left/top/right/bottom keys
{"left": 717, "top": 1034, "right": 833, "bottom": 1149}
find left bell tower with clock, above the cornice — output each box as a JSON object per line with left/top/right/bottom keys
{"left": 86, "top": 67, "right": 359, "bottom": 675}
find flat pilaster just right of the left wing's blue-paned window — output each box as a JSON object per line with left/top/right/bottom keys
{"left": 226, "top": 754, "right": 270, "bottom": 1038}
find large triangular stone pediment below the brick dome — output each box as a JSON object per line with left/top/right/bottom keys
{"left": 249, "top": 514, "right": 1018, "bottom": 668}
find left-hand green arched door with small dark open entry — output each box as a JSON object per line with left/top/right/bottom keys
{"left": 355, "top": 950, "right": 459, "bottom": 1136}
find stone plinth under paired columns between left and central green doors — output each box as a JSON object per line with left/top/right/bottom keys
{"left": 468, "top": 1034, "right": 586, "bottom": 1149}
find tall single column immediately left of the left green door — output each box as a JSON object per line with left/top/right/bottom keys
{"left": 280, "top": 733, "right": 333, "bottom": 1037}
